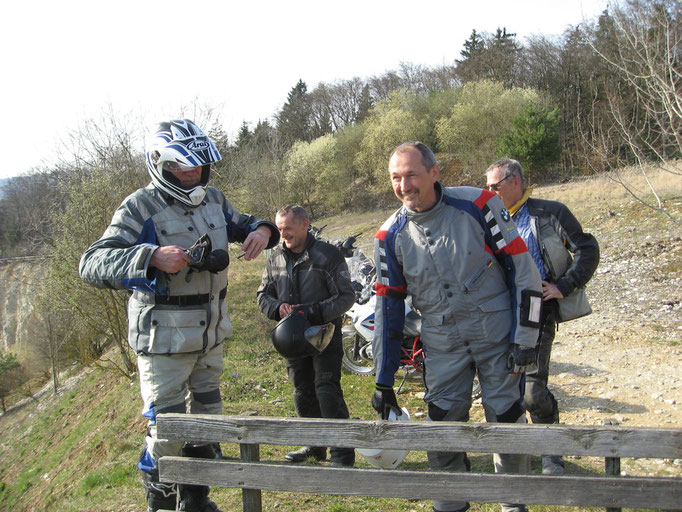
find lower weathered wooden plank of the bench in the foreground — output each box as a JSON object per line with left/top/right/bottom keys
{"left": 159, "top": 457, "right": 682, "bottom": 509}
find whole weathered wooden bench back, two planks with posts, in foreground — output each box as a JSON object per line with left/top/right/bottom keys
{"left": 157, "top": 414, "right": 682, "bottom": 512}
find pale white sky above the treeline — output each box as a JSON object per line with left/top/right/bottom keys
{"left": 0, "top": 0, "right": 607, "bottom": 178}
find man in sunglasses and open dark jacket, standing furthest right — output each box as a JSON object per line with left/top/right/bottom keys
{"left": 486, "top": 158, "right": 599, "bottom": 475}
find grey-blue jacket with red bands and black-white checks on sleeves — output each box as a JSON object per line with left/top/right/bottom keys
{"left": 373, "top": 182, "right": 542, "bottom": 386}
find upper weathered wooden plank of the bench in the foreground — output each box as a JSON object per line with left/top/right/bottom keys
{"left": 157, "top": 414, "right": 682, "bottom": 459}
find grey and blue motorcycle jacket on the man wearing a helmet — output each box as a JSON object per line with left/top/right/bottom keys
{"left": 79, "top": 184, "right": 279, "bottom": 354}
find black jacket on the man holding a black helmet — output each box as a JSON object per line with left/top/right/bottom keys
{"left": 257, "top": 233, "right": 355, "bottom": 327}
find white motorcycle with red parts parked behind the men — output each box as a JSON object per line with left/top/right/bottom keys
{"left": 316, "top": 226, "right": 483, "bottom": 400}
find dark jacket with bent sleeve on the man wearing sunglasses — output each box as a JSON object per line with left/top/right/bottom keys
{"left": 526, "top": 198, "right": 599, "bottom": 297}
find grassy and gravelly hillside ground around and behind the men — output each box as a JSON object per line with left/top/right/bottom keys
{"left": 0, "top": 169, "right": 682, "bottom": 512}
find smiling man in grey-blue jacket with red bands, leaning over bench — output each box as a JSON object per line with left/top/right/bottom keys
{"left": 372, "top": 142, "right": 542, "bottom": 512}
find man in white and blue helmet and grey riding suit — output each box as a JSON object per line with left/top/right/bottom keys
{"left": 79, "top": 119, "right": 279, "bottom": 512}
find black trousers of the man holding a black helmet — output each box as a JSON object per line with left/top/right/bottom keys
{"left": 287, "top": 326, "right": 354, "bottom": 462}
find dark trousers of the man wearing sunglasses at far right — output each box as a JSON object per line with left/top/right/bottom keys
{"left": 523, "top": 300, "right": 559, "bottom": 424}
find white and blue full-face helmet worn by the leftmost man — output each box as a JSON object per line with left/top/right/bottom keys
{"left": 147, "top": 119, "right": 222, "bottom": 206}
